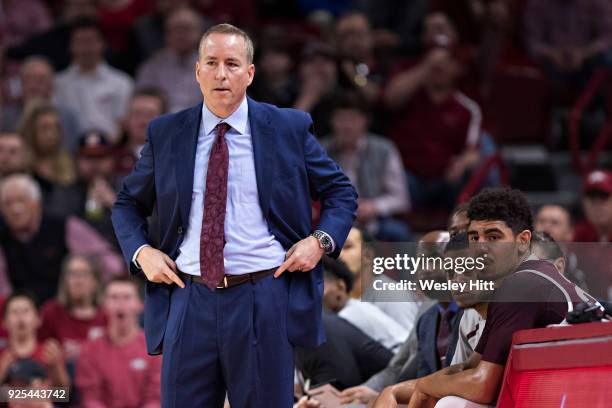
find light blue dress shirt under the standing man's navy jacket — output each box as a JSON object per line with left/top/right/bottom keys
{"left": 176, "top": 98, "right": 285, "bottom": 275}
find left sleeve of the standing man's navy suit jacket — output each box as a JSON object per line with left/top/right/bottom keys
{"left": 112, "top": 125, "right": 155, "bottom": 272}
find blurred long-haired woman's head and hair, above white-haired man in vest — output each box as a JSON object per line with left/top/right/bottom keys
{"left": 17, "top": 103, "right": 76, "bottom": 190}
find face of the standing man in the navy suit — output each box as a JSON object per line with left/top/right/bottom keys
{"left": 196, "top": 33, "right": 255, "bottom": 118}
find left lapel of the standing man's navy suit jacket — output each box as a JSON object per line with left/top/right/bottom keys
{"left": 172, "top": 103, "right": 202, "bottom": 223}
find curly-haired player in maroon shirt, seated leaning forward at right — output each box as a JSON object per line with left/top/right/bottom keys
{"left": 374, "top": 189, "right": 597, "bottom": 408}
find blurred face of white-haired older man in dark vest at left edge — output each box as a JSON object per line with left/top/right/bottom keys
{"left": 0, "top": 184, "right": 41, "bottom": 232}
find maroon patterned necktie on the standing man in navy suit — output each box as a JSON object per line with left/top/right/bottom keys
{"left": 200, "top": 123, "right": 229, "bottom": 290}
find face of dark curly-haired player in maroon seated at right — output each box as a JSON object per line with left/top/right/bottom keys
{"left": 468, "top": 220, "right": 531, "bottom": 280}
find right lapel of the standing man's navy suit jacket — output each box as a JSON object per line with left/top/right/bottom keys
{"left": 247, "top": 98, "right": 276, "bottom": 217}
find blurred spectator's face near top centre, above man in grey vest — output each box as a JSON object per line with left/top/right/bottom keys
{"left": 336, "top": 15, "right": 374, "bottom": 62}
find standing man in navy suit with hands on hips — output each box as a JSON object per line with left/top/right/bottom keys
{"left": 113, "top": 24, "right": 357, "bottom": 408}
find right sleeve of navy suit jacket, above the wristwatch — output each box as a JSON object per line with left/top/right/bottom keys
{"left": 304, "top": 113, "right": 357, "bottom": 257}
